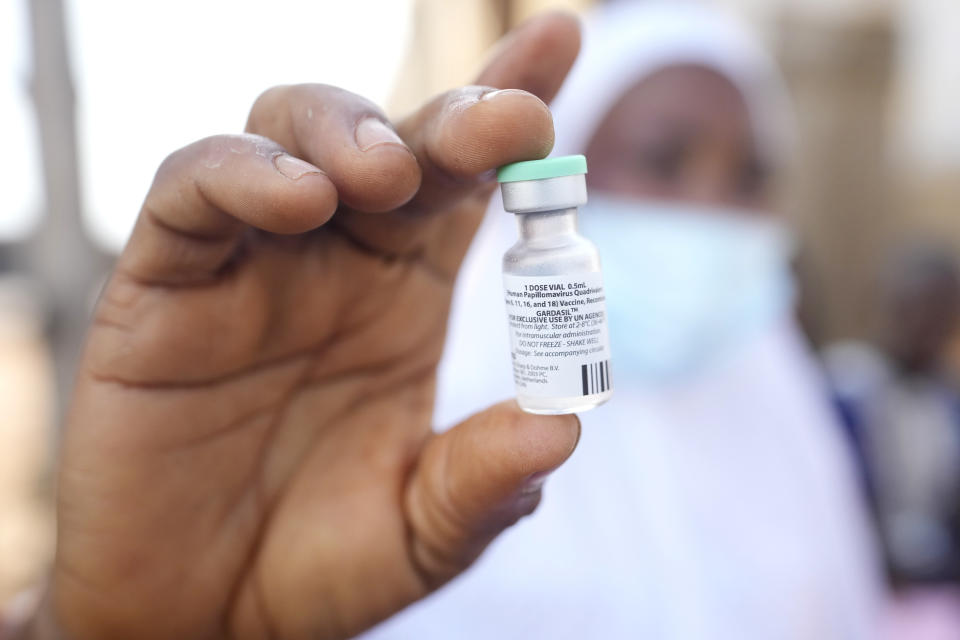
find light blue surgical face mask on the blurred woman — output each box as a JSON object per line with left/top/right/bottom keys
{"left": 580, "top": 196, "right": 794, "bottom": 380}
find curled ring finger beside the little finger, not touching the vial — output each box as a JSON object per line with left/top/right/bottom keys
{"left": 247, "top": 84, "right": 420, "bottom": 212}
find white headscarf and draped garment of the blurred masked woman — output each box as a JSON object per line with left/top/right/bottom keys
{"left": 364, "top": 4, "right": 879, "bottom": 640}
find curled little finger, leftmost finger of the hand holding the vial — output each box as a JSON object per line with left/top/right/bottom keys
{"left": 118, "top": 135, "right": 337, "bottom": 284}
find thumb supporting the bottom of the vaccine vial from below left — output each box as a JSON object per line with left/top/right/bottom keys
{"left": 405, "top": 400, "right": 580, "bottom": 590}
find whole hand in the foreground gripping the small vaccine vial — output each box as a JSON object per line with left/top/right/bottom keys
{"left": 30, "top": 15, "right": 579, "bottom": 640}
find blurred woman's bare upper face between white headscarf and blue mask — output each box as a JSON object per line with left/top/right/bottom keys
{"left": 587, "top": 65, "right": 770, "bottom": 211}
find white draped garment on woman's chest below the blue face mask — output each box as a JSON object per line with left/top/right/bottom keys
{"left": 365, "top": 320, "right": 877, "bottom": 640}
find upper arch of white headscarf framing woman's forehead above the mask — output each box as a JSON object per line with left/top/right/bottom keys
{"left": 551, "top": 0, "right": 795, "bottom": 168}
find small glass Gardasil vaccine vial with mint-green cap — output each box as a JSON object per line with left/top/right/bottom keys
{"left": 497, "top": 155, "right": 613, "bottom": 414}
